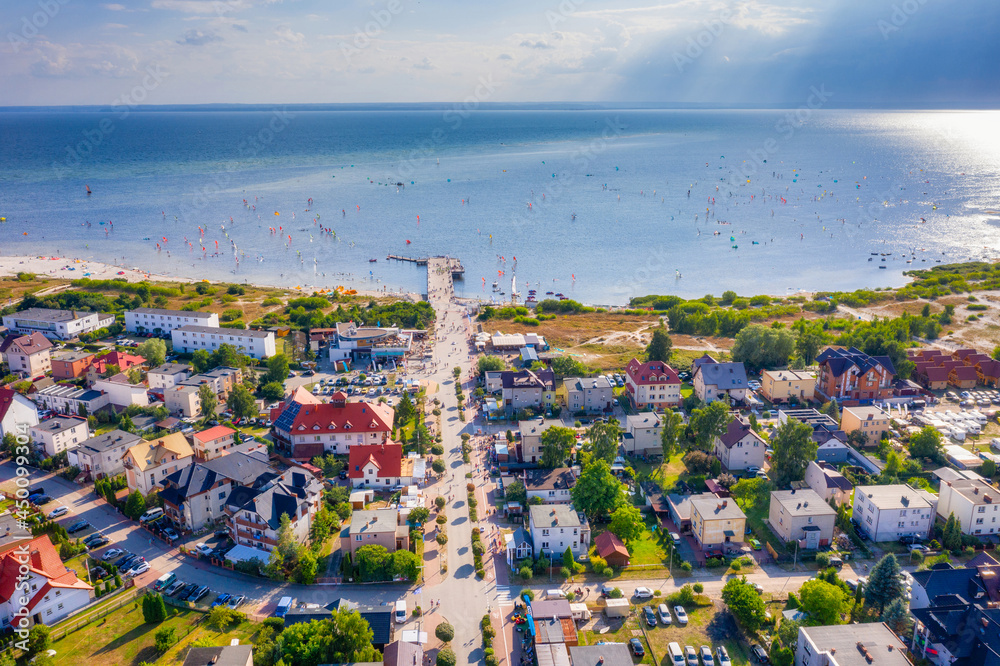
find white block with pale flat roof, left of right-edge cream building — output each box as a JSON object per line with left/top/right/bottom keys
{"left": 851, "top": 483, "right": 938, "bottom": 541}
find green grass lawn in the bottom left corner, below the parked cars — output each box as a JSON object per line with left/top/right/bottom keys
{"left": 52, "top": 601, "right": 257, "bottom": 666}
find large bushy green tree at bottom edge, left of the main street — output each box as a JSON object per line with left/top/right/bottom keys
{"left": 279, "top": 608, "right": 382, "bottom": 666}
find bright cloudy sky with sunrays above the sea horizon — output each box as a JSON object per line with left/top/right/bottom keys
{"left": 0, "top": 0, "right": 1000, "bottom": 108}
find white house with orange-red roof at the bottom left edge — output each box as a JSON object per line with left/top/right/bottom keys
{"left": 0, "top": 534, "right": 94, "bottom": 627}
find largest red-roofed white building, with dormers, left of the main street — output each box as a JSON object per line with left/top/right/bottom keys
{"left": 284, "top": 392, "right": 393, "bottom": 461}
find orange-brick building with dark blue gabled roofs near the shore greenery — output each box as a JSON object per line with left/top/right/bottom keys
{"left": 816, "top": 347, "right": 896, "bottom": 402}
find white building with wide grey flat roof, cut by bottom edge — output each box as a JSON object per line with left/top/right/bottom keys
{"left": 795, "top": 622, "right": 913, "bottom": 666}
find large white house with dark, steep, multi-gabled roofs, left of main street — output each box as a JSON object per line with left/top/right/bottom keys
{"left": 225, "top": 464, "right": 322, "bottom": 552}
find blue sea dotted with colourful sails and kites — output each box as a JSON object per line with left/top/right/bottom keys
{"left": 0, "top": 104, "right": 1000, "bottom": 305}
